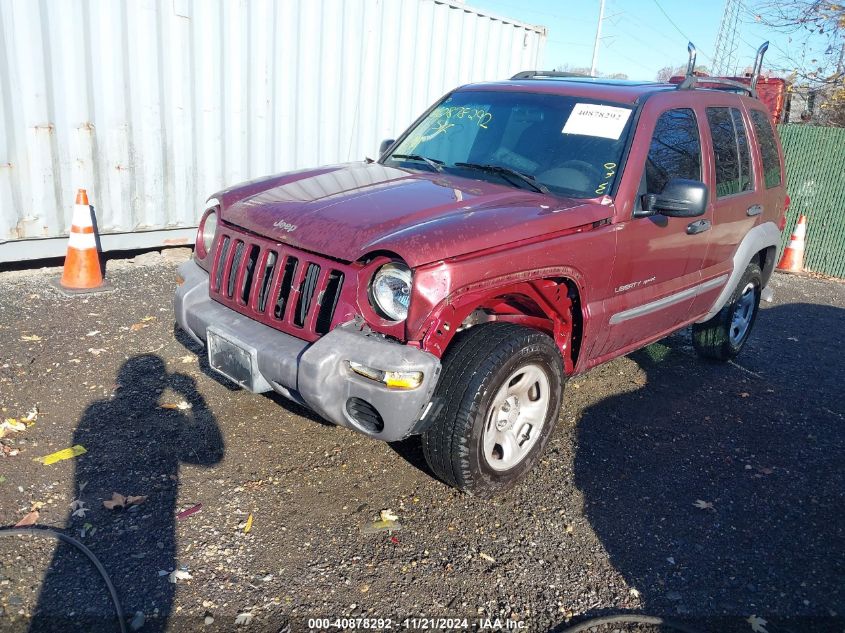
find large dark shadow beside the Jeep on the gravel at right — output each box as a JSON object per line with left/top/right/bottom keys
{"left": 575, "top": 304, "right": 845, "bottom": 631}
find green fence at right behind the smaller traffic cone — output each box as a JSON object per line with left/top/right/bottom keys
{"left": 778, "top": 125, "right": 845, "bottom": 278}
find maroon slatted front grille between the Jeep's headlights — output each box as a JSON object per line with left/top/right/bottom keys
{"left": 210, "top": 228, "right": 349, "bottom": 341}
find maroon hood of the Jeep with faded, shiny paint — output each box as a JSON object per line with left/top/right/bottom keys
{"left": 215, "top": 163, "right": 612, "bottom": 267}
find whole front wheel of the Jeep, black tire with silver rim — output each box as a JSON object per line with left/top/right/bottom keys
{"left": 422, "top": 323, "right": 564, "bottom": 497}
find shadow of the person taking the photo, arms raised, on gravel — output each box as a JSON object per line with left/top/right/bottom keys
{"left": 30, "top": 354, "right": 224, "bottom": 632}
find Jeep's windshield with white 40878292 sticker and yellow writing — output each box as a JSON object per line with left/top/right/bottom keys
{"left": 385, "top": 90, "right": 632, "bottom": 198}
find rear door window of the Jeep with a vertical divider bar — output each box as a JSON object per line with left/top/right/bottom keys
{"left": 707, "top": 108, "right": 754, "bottom": 198}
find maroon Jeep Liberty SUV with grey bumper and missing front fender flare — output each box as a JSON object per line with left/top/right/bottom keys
{"left": 174, "top": 55, "right": 787, "bottom": 496}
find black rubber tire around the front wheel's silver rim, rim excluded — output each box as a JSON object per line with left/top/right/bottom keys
{"left": 422, "top": 323, "right": 564, "bottom": 497}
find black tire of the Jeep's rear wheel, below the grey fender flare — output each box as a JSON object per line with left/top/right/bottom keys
{"left": 692, "top": 262, "right": 763, "bottom": 361}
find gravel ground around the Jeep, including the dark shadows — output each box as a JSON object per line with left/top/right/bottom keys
{"left": 0, "top": 255, "right": 845, "bottom": 633}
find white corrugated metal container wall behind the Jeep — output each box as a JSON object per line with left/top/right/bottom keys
{"left": 0, "top": 0, "right": 545, "bottom": 261}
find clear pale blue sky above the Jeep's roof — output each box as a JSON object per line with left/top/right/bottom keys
{"left": 467, "top": 0, "right": 804, "bottom": 80}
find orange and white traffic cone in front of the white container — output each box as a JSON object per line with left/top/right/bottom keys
{"left": 54, "top": 189, "right": 111, "bottom": 294}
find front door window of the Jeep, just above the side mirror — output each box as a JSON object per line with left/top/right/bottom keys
{"left": 645, "top": 108, "right": 701, "bottom": 193}
